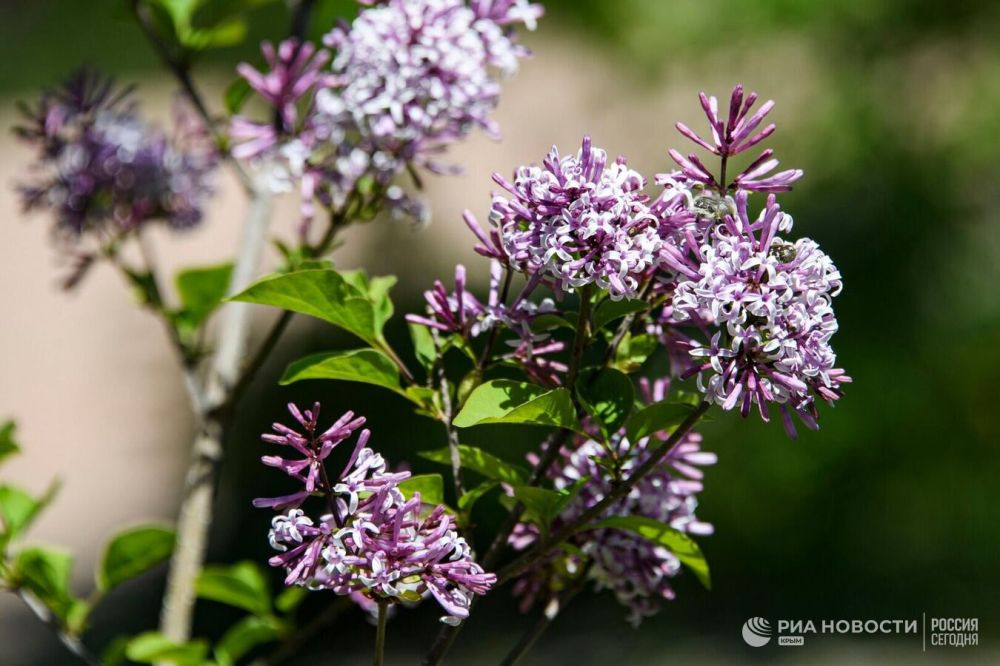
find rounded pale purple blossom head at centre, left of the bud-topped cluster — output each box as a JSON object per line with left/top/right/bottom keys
{"left": 466, "top": 137, "right": 662, "bottom": 300}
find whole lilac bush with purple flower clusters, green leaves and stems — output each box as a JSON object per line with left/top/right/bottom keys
{"left": 0, "top": 0, "right": 851, "bottom": 664}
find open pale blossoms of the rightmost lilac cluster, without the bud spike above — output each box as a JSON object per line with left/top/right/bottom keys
{"left": 664, "top": 191, "right": 851, "bottom": 436}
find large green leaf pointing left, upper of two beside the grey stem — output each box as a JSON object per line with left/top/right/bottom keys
{"left": 231, "top": 270, "right": 381, "bottom": 345}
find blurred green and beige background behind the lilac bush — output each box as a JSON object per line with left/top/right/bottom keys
{"left": 0, "top": 0, "right": 1000, "bottom": 665}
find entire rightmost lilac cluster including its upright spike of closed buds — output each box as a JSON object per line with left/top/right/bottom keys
{"left": 657, "top": 86, "right": 851, "bottom": 437}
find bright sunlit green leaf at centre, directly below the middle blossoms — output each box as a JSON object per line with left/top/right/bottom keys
{"left": 452, "top": 379, "right": 580, "bottom": 430}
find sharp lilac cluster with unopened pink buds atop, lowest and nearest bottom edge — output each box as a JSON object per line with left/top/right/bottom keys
{"left": 254, "top": 403, "right": 496, "bottom": 624}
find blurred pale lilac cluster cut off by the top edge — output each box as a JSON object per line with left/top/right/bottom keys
{"left": 231, "top": 0, "right": 541, "bottom": 228}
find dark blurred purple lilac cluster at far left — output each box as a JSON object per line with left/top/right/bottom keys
{"left": 15, "top": 70, "right": 216, "bottom": 244}
